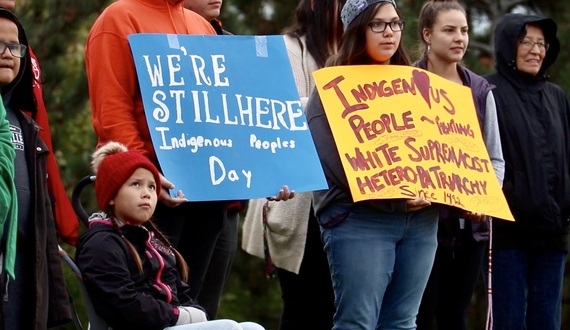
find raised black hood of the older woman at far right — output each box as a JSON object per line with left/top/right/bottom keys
{"left": 494, "top": 14, "right": 560, "bottom": 79}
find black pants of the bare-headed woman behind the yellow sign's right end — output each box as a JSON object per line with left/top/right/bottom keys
{"left": 416, "top": 227, "right": 487, "bottom": 330}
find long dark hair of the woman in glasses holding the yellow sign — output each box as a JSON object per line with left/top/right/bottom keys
{"left": 326, "top": 2, "right": 410, "bottom": 66}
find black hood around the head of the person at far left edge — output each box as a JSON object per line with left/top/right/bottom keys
{"left": 0, "top": 7, "right": 37, "bottom": 114}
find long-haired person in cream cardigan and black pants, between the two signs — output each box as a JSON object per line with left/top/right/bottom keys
{"left": 242, "top": 0, "right": 346, "bottom": 330}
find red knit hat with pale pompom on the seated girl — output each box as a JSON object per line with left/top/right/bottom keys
{"left": 91, "top": 141, "right": 160, "bottom": 211}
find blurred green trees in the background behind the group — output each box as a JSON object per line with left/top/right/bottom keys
{"left": 12, "top": 0, "right": 570, "bottom": 330}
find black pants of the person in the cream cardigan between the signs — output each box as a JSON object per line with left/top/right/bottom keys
{"left": 277, "top": 210, "right": 335, "bottom": 330}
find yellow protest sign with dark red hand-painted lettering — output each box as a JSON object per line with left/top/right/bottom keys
{"left": 313, "top": 65, "right": 513, "bottom": 220}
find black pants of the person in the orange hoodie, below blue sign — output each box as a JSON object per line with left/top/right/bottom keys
{"left": 154, "top": 201, "right": 227, "bottom": 300}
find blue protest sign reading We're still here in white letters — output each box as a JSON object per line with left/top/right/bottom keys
{"left": 129, "top": 34, "right": 327, "bottom": 201}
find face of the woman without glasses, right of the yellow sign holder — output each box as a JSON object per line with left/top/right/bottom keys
{"left": 424, "top": 9, "right": 469, "bottom": 63}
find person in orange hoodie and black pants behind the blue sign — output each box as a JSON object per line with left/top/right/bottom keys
{"left": 85, "top": 0, "right": 227, "bottom": 314}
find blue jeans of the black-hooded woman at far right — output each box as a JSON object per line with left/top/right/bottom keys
{"left": 491, "top": 249, "right": 566, "bottom": 330}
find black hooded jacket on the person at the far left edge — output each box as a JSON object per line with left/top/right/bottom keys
{"left": 0, "top": 7, "right": 72, "bottom": 330}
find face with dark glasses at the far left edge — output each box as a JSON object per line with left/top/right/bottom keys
{"left": 0, "top": 17, "right": 20, "bottom": 87}
